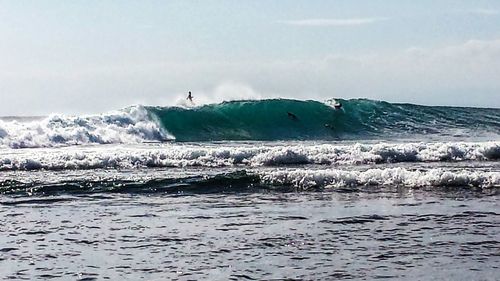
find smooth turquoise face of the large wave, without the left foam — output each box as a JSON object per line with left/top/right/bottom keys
{"left": 147, "top": 99, "right": 500, "bottom": 141}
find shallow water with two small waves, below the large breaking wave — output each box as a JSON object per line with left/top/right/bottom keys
{"left": 0, "top": 139, "right": 500, "bottom": 280}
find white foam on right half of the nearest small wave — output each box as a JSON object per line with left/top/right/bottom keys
{"left": 259, "top": 167, "right": 500, "bottom": 189}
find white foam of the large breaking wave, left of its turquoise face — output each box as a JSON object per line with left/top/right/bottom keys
{"left": 0, "top": 106, "right": 171, "bottom": 148}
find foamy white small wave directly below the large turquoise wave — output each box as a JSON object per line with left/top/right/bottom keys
{"left": 0, "top": 142, "right": 500, "bottom": 171}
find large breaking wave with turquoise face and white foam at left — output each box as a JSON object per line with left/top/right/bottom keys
{"left": 0, "top": 99, "right": 500, "bottom": 148}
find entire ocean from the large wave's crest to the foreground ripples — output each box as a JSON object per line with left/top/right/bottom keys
{"left": 0, "top": 99, "right": 500, "bottom": 280}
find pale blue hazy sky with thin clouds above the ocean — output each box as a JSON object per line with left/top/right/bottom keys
{"left": 0, "top": 0, "right": 500, "bottom": 116}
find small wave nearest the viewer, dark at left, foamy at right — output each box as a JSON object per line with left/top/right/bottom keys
{"left": 0, "top": 167, "right": 500, "bottom": 197}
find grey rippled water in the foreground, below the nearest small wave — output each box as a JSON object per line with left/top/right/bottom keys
{"left": 0, "top": 187, "right": 500, "bottom": 280}
